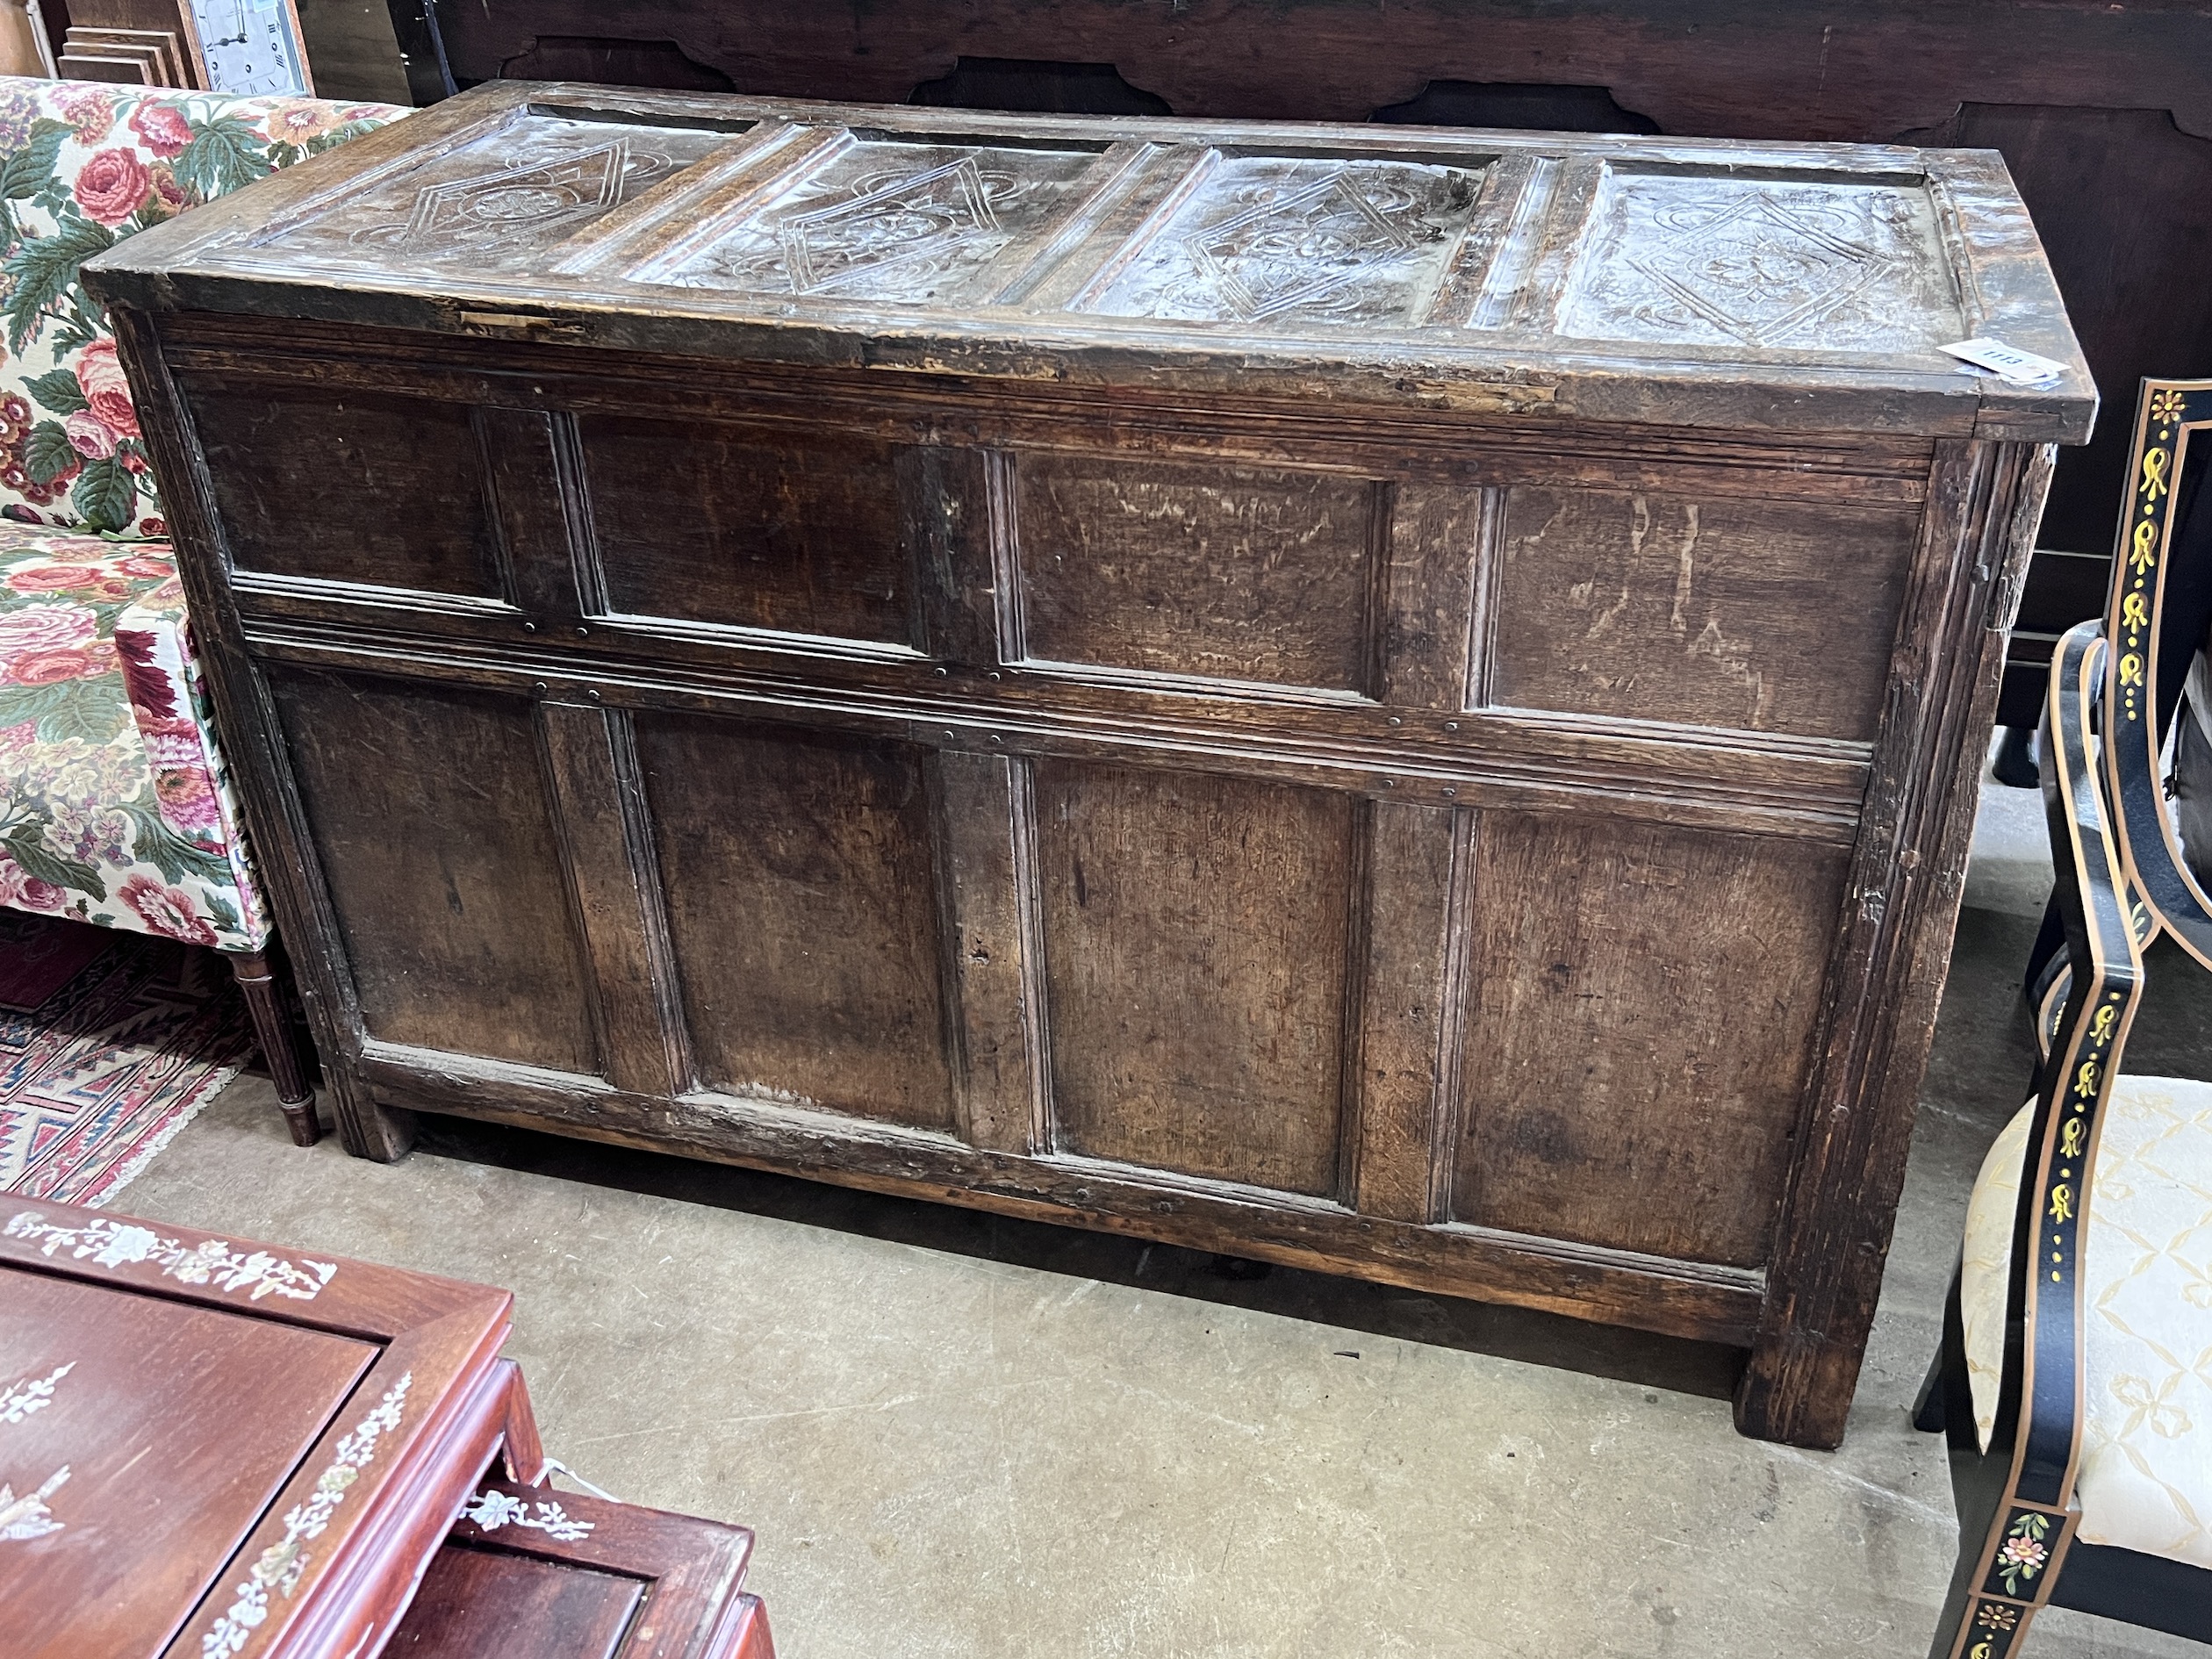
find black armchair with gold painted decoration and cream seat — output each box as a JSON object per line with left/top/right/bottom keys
{"left": 1915, "top": 380, "right": 2212, "bottom": 1659}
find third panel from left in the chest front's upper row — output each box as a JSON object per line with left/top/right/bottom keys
{"left": 1016, "top": 454, "right": 1382, "bottom": 694}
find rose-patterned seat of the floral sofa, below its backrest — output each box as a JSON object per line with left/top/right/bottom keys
{"left": 0, "top": 524, "right": 269, "bottom": 952}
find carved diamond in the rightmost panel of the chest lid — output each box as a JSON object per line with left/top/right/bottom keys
{"left": 1628, "top": 190, "right": 1902, "bottom": 345}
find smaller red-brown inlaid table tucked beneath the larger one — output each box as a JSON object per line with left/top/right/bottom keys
{"left": 384, "top": 1480, "right": 774, "bottom": 1659}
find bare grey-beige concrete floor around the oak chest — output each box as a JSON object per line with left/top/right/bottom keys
{"left": 118, "top": 786, "right": 2212, "bottom": 1659}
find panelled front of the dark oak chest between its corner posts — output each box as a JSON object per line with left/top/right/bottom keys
{"left": 170, "top": 320, "right": 1931, "bottom": 1269}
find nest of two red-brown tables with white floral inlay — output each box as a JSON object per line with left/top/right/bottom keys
{"left": 0, "top": 1199, "right": 774, "bottom": 1659}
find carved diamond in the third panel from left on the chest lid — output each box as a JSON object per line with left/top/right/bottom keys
{"left": 1183, "top": 173, "right": 1413, "bottom": 323}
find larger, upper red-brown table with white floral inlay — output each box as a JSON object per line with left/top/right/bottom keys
{"left": 0, "top": 1199, "right": 544, "bottom": 1659}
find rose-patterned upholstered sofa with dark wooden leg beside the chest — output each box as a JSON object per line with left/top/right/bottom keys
{"left": 0, "top": 77, "right": 407, "bottom": 1144}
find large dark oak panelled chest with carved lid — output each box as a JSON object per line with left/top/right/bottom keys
{"left": 86, "top": 84, "right": 2094, "bottom": 1445}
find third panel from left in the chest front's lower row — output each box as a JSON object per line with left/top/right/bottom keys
{"left": 1035, "top": 761, "right": 1358, "bottom": 1195}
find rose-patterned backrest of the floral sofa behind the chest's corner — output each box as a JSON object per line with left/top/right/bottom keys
{"left": 0, "top": 77, "right": 407, "bottom": 535}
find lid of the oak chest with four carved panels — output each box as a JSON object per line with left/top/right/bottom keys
{"left": 86, "top": 82, "right": 2097, "bottom": 442}
